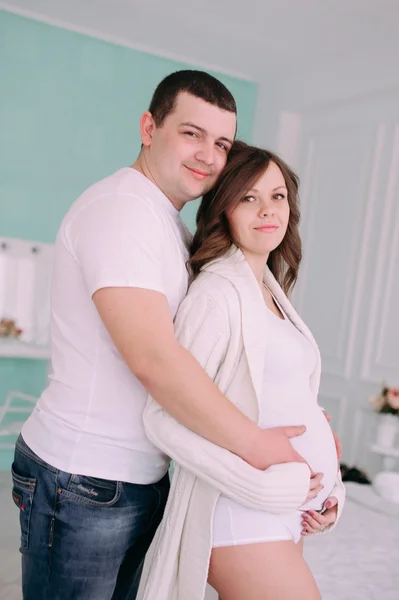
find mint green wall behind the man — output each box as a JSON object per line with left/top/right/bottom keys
{"left": 0, "top": 12, "right": 257, "bottom": 468}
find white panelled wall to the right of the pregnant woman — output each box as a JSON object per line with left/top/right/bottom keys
{"left": 255, "top": 78, "right": 399, "bottom": 474}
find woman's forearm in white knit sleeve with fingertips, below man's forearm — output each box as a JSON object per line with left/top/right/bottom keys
{"left": 143, "top": 397, "right": 322, "bottom": 513}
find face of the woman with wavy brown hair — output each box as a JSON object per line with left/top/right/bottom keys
{"left": 226, "top": 162, "right": 290, "bottom": 260}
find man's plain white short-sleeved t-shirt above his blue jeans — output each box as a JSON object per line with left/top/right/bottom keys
{"left": 22, "top": 168, "right": 191, "bottom": 484}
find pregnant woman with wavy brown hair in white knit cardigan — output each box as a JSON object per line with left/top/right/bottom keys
{"left": 139, "top": 142, "right": 344, "bottom": 600}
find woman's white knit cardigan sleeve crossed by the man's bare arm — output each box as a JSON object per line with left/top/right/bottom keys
{"left": 143, "top": 294, "right": 310, "bottom": 513}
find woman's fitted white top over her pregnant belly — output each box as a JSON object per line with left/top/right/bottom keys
{"left": 259, "top": 307, "right": 338, "bottom": 510}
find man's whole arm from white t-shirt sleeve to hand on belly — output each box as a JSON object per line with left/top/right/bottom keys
{"left": 71, "top": 193, "right": 303, "bottom": 469}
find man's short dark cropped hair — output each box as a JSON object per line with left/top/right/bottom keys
{"left": 148, "top": 70, "right": 237, "bottom": 127}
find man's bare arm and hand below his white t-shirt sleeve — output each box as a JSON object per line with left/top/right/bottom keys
{"left": 93, "top": 287, "right": 305, "bottom": 469}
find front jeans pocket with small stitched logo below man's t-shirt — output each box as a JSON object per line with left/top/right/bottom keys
{"left": 58, "top": 474, "right": 122, "bottom": 507}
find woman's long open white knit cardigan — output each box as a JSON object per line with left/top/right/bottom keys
{"left": 137, "top": 247, "right": 345, "bottom": 600}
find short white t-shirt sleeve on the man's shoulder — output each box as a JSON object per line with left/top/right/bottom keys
{"left": 65, "top": 195, "right": 165, "bottom": 296}
